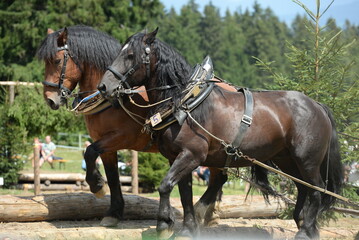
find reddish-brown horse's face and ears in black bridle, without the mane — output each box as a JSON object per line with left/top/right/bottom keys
{"left": 43, "top": 28, "right": 82, "bottom": 110}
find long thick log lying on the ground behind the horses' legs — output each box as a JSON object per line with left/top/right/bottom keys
{"left": 0, "top": 193, "right": 281, "bottom": 222}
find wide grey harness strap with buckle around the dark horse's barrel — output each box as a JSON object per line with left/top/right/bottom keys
{"left": 222, "top": 88, "right": 254, "bottom": 174}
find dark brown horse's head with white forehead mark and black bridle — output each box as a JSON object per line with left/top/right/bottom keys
{"left": 98, "top": 28, "right": 158, "bottom": 100}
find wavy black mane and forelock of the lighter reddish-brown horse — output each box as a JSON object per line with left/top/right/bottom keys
{"left": 36, "top": 25, "right": 121, "bottom": 71}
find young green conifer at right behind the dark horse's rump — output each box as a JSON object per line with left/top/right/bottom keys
{"left": 257, "top": 1, "right": 359, "bottom": 165}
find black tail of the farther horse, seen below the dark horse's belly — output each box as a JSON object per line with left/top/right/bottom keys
{"left": 252, "top": 161, "right": 277, "bottom": 202}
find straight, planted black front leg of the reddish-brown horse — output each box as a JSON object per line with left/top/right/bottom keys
{"left": 100, "top": 152, "right": 125, "bottom": 227}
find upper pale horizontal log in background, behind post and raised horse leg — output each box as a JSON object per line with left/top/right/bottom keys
{"left": 19, "top": 172, "right": 132, "bottom": 183}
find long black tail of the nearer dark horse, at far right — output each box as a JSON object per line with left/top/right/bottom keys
{"left": 320, "top": 104, "right": 344, "bottom": 211}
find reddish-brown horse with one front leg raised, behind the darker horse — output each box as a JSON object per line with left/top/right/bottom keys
{"left": 37, "top": 26, "right": 224, "bottom": 226}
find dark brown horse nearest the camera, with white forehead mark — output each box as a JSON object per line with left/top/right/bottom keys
{"left": 98, "top": 28, "right": 343, "bottom": 239}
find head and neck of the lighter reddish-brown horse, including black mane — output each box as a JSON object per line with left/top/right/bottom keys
{"left": 37, "top": 25, "right": 121, "bottom": 109}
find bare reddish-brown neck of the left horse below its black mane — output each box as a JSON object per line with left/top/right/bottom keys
{"left": 79, "top": 66, "right": 104, "bottom": 96}
